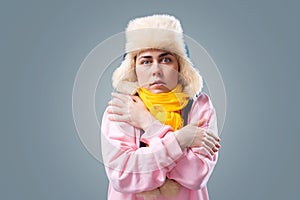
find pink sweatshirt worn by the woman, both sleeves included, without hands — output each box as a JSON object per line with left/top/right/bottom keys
{"left": 101, "top": 93, "right": 218, "bottom": 200}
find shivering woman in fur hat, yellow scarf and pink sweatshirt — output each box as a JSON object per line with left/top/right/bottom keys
{"left": 101, "top": 15, "right": 220, "bottom": 200}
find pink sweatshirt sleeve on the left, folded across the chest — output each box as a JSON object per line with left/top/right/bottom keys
{"left": 101, "top": 111, "right": 183, "bottom": 193}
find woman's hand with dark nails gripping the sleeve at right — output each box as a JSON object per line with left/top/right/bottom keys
{"left": 175, "top": 118, "right": 221, "bottom": 155}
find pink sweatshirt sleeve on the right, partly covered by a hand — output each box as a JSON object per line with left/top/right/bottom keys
{"left": 167, "top": 93, "right": 218, "bottom": 190}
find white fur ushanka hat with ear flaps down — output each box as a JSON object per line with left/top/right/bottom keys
{"left": 112, "top": 15, "right": 203, "bottom": 98}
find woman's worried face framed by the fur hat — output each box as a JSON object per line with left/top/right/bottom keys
{"left": 136, "top": 49, "right": 179, "bottom": 94}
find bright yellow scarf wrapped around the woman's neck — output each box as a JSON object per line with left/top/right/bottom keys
{"left": 138, "top": 85, "right": 189, "bottom": 131}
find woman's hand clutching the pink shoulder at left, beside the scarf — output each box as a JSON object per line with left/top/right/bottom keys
{"left": 107, "top": 93, "right": 155, "bottom": 130}
